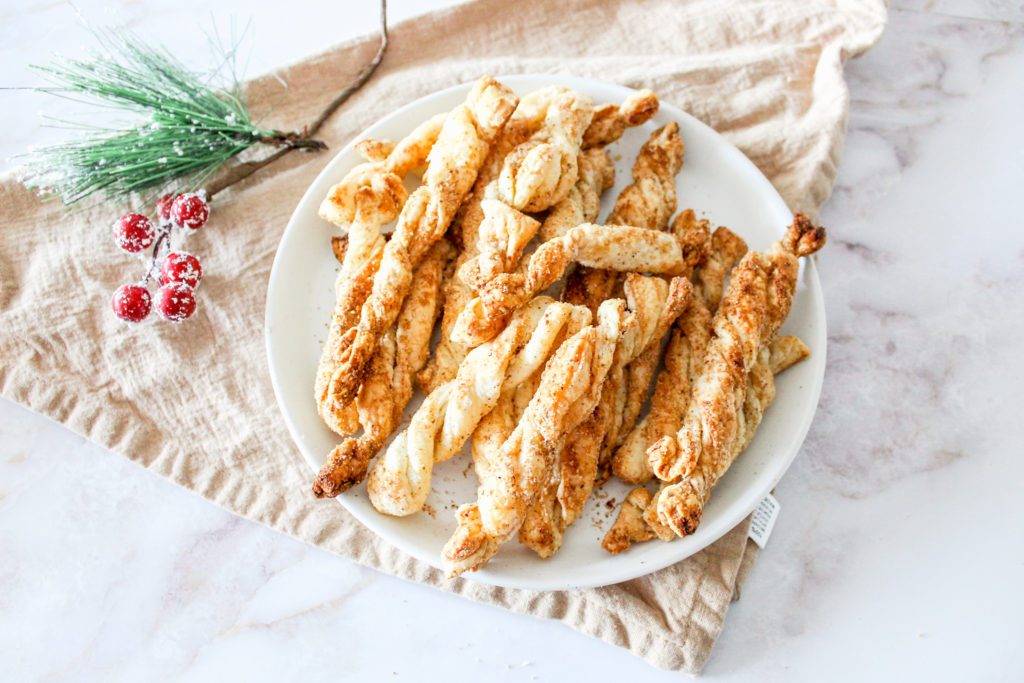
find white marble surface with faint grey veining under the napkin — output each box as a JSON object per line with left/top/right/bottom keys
{"left": 0, "top": 0, "right": 1024, "bottom": 681}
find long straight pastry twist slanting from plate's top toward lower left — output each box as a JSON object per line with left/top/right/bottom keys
{"left": 330, "top": 77, "right": 517, "bottom": 403}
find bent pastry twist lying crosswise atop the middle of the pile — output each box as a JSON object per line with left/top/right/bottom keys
{"left": 452, "top": 223, "right": 683, "bottom": 346}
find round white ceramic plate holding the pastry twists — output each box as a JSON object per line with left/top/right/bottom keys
{"left": 266, "top": 75, "right": 825, "bottom": 590}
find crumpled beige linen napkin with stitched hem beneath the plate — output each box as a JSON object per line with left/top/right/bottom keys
{"left": 0, "top": 0, "right": 886, "bottom": 674}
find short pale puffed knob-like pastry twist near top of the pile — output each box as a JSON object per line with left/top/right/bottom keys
{"left": 498, "top": 90, "right": 594, "bottom": 212}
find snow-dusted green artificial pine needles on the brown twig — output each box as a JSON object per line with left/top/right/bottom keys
{"left": 24, "top": 32, "right": 324, "bottom": 204}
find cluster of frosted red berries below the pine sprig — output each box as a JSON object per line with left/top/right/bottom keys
{"left": 111, "top": 189, "right": 210, "bottom": 323}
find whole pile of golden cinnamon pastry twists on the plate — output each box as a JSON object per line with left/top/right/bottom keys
{"left": 313, "top": 77, "right": 824, "bottom": 575}
